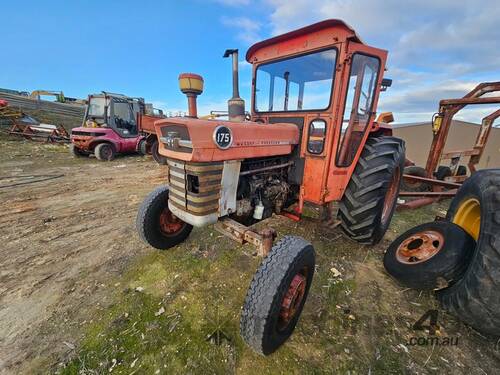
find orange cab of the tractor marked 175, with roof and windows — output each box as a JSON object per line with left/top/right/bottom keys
{"left": 246, "top": 20, "right": 390, "bottom": 204}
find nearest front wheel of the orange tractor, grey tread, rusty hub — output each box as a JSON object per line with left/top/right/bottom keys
{"left": 240, "top": 236, "right": 315, "bottom": 355}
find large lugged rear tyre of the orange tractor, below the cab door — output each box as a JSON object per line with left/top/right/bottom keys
{"left": 339, "top": 136, "right": 405, "bottom": 245}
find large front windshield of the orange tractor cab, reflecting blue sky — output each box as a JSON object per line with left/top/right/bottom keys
{"left": 255, "top": 48, "right": 337, "bottom": 112}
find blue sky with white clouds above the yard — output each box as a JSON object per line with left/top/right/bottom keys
{"left": 0, "top": 0, "right": 500, "bottom": 122}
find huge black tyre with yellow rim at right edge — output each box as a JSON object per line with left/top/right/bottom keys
{"left": 437, "top": 169, "right": 500, "bottom": 337}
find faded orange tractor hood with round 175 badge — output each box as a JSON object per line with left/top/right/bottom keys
{"left": 155, "top": 117, "right": 299, "bottom": 162}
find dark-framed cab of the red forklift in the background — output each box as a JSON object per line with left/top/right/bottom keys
{"left": 83, "top": 92, "right": 144, "bottom": 137}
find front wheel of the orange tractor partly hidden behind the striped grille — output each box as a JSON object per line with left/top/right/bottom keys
{"left": 136, "top": 186, "right": 193, "bottom": 250}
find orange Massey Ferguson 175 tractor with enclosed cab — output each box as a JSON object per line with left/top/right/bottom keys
{"left": 136, "top": 20, "right": 405, "bottom": 355}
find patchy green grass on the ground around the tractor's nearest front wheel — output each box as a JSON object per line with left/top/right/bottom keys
{"left": 53, "top": 201, "right": 458, "bottom": 374}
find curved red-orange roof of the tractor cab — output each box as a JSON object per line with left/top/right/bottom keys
{"left": 246, "top": 19, "right": 363, "bottom": 63}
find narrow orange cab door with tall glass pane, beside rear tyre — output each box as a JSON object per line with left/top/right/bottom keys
{"left": 325, "top": 42, "right": 387, "bottom": 202}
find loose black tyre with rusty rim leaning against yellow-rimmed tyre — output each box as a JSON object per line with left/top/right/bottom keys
{"left": 384, "top": 221, "right": 476, "bottom": 290}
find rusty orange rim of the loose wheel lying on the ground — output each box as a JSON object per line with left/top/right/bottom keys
{"left": 396, "top": 230, "right": 444, "bottom": 265}
